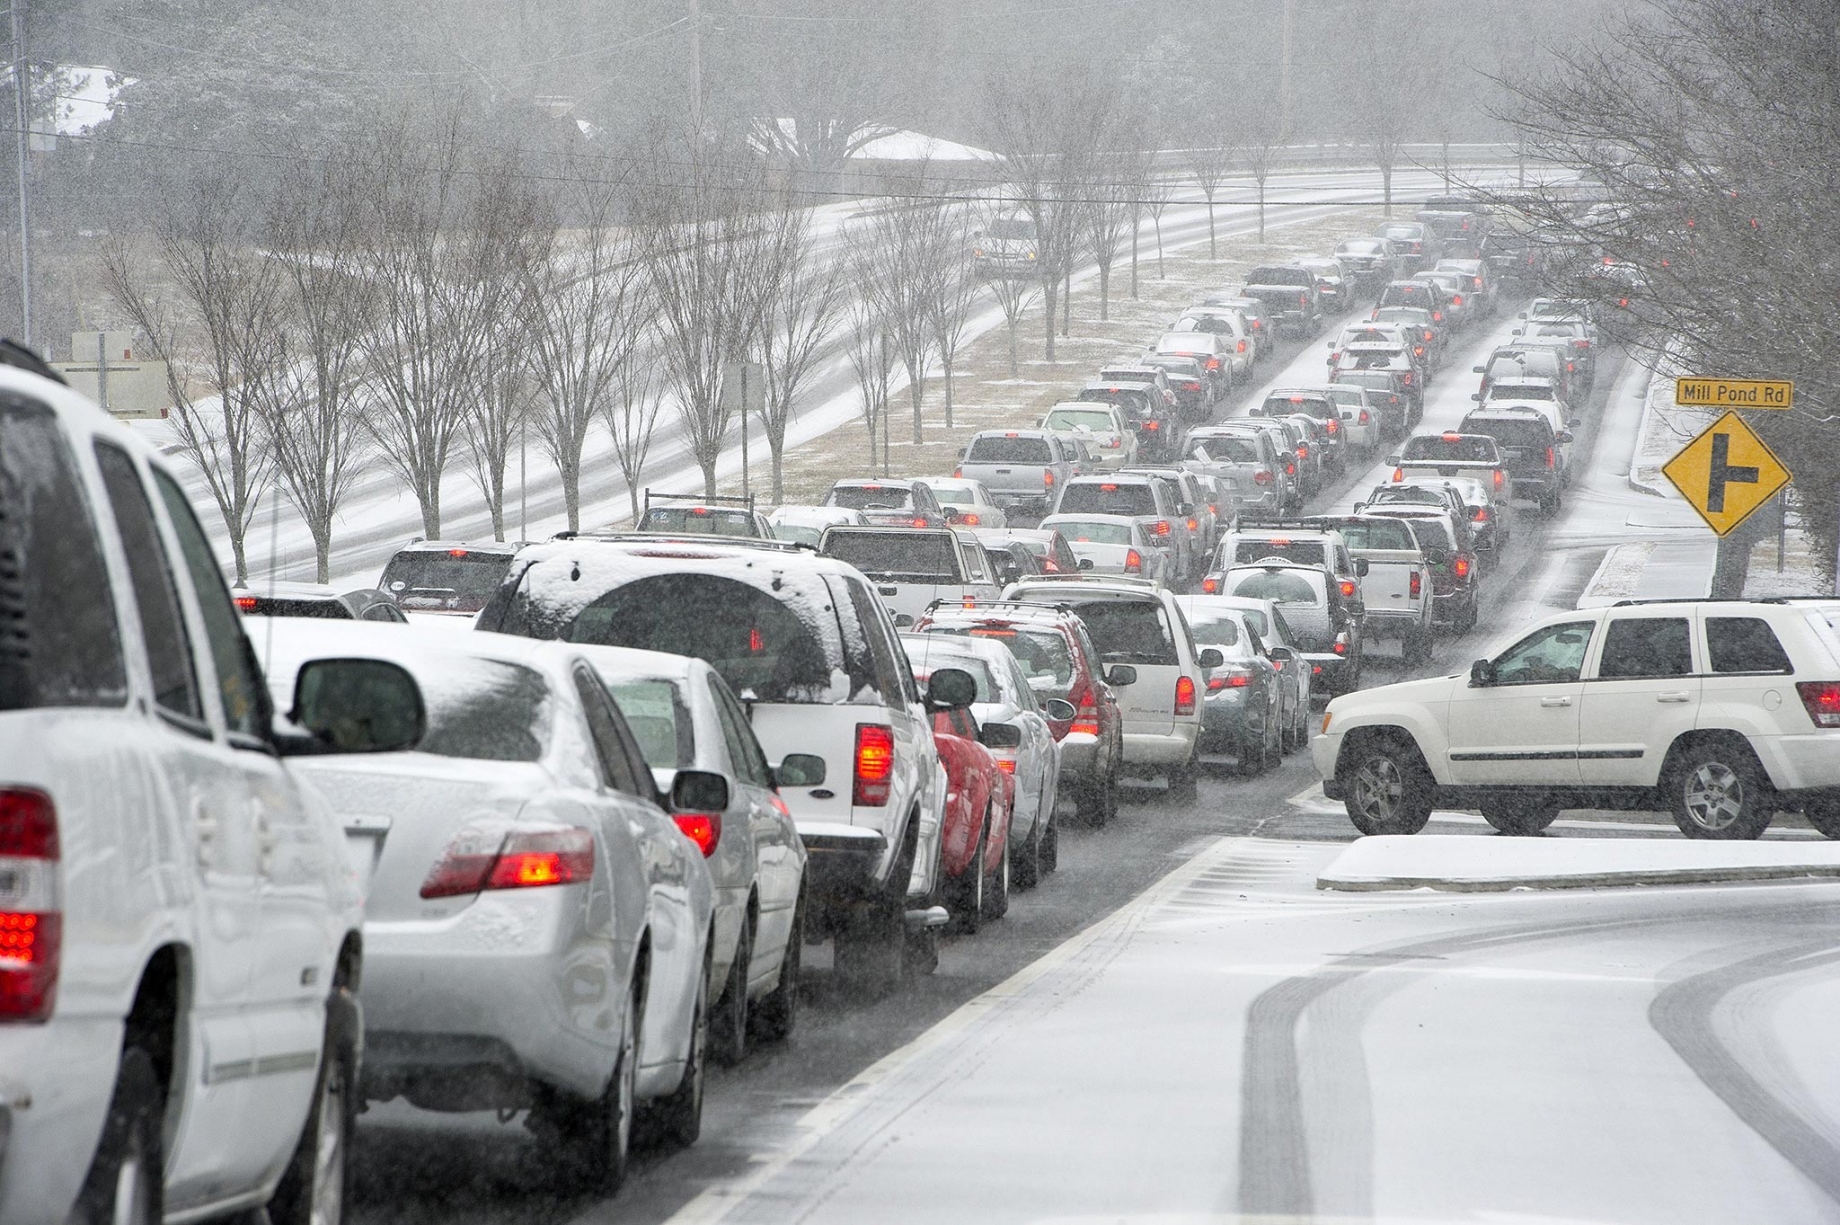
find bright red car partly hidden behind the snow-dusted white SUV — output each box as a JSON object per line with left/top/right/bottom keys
{"left": 914, "top": 668, "right": 1016, "bottom": 934}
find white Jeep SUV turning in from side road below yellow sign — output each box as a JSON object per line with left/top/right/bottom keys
{"left": 1312, "top": 600, "right": 1840, "bottom": 839}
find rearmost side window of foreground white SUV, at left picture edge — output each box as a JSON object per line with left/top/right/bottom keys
{"left": 0, "top": 401, "right": 127, "bottom": 710}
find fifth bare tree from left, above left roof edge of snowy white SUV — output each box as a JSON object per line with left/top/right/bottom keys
{"left": 523, "top": 160, "right": 646, "bottom": 532}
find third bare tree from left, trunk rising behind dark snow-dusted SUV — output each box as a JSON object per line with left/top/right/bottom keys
{"left": 351, "top": 118, "right": 495, "bottom": 539}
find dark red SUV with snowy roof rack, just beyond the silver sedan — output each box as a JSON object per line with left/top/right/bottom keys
{"left": 914, "top": 600, "right": 1124, "bottom": 826}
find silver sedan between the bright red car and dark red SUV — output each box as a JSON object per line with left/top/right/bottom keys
{"left": 902, "top": 633, "right": 1075, "bottom": 888}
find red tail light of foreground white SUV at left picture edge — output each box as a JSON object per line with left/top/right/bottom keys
{"left": 0, "top": 787, "right": 64, "bottom": 1021}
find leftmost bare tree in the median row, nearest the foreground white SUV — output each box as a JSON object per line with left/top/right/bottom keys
{"left": 103, "top": 175, "right": 283, "bottom": 583}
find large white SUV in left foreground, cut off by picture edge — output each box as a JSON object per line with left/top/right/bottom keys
{"left": 0, "top": 357, "right": 406, "bottom": 1225}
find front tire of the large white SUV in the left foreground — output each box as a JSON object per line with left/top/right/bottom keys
{"left": 269, "top": 986, "right": 364, "bottom": 1225}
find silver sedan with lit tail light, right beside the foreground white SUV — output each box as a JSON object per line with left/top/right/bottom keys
{"left": 263, "top": 618, "right": 727, "bottom": 1190}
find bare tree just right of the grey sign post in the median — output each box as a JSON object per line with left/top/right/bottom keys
{"left": 760, "top": 212, "right": 843, "bottom": 502}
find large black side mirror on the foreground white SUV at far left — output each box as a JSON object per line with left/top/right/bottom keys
{"left": 276, "top": 658, "right": 429, "bottom": 758}
